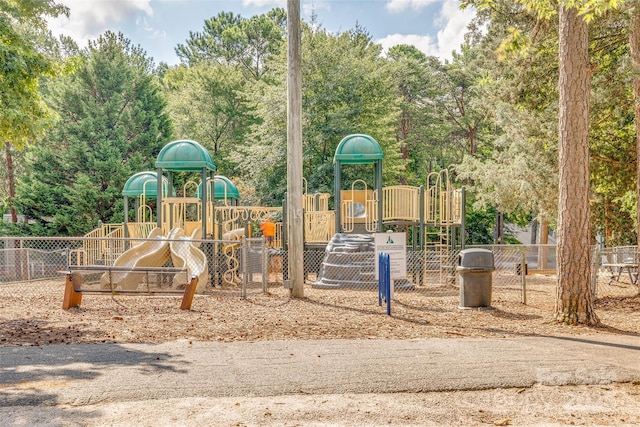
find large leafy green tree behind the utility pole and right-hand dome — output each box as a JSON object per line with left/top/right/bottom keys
{"left": 235, "top": 23, "right": 402, "bottom": 204}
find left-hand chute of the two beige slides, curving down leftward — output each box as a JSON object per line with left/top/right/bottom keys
{"left": 100, "top": 228, "right": 173, "bottom": 290}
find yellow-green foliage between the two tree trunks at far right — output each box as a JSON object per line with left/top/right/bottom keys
{"left": 589, "top": 11, "right": 637, "bottom": 246}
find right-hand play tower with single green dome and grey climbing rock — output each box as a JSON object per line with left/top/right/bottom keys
{"left": 314, "top": 134, "right": 464, "bottom": 288}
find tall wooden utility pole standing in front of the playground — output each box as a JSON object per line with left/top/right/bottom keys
{"left": 286, "top": 0, "right": 304, "bottom": 297}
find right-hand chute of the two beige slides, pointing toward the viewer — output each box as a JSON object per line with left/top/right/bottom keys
{"left": 169, "top": 228, "right": 209, "bottom": 294}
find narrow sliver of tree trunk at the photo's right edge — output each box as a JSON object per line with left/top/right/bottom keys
{"left": 629, "top": 0, "right": 640, "bottom": 254}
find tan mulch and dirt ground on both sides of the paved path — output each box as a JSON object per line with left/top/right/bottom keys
{"left": 0, "top": 276, "right": 640, "bottom": 426}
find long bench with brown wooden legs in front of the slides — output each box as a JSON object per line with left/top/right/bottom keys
{"left": 61, "top": 265, "right": 198, "bottom": 310}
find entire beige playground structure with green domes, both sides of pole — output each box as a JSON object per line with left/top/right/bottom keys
{"left": 69, "top": 134, "right": 464, "bottom": 291}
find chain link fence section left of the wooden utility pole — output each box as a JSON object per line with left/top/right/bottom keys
{"left": 0, "top": 235, "right": 283, "bottom": 297}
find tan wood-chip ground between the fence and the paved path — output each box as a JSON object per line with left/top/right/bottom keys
{"left": 0, "top": 276, "right": 640, "bottom": 346}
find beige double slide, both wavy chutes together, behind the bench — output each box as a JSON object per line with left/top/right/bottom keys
{"left": 100, "top": 228, "right": 208, "bottom": 293}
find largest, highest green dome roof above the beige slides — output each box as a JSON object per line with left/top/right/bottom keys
{"left": 156, "top": 139, "right": 216, "bottom": 172}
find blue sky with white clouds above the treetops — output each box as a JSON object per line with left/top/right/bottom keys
{"left": 49, "top": 0, "right": 475, "bottom": 65}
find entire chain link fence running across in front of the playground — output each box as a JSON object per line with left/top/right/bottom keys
{"left": 0, "top": 236, "right": 638, "bottom": 306}
